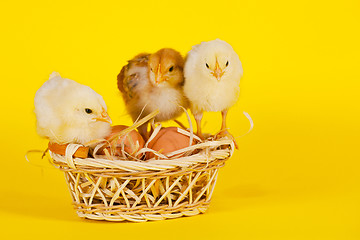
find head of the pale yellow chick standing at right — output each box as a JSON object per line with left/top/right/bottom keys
{"left": 185, "top": 39, "right": 243, "bottom": 82}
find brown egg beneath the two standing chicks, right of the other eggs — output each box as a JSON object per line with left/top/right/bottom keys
{"left": 146, "top": 127, "right": 196, "bottom": 159}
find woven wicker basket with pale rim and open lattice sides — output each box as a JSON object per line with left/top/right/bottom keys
{"left": 50, "top": 139, "right": 234, "bottom": 222}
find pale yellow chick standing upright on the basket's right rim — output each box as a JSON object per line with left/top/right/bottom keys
{"left": 184, "top": 39, "right": 243, "bottom": 146}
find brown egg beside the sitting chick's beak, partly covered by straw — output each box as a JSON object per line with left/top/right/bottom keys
{"left": 100, "top": 125, "right": 145, "bottom": 156}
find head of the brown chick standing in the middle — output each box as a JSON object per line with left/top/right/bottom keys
{"left": 148, "top": 48, "right": 184, "bottom": 87}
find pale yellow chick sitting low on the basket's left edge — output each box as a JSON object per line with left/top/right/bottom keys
{"left": 34, "top": 72, "right": 111, "bottom": 144}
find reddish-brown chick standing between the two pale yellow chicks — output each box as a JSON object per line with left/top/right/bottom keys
{"left": 117, "top": 48, "right": 187, "bottom": 139}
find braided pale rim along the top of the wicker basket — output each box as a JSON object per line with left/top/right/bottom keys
{"left": 49, "top": 138, "right": 234, "bottom": 173}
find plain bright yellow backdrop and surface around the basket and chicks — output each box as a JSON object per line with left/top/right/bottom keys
{"left": 0, "top": 0, "right": 360, "bottom": 239}
